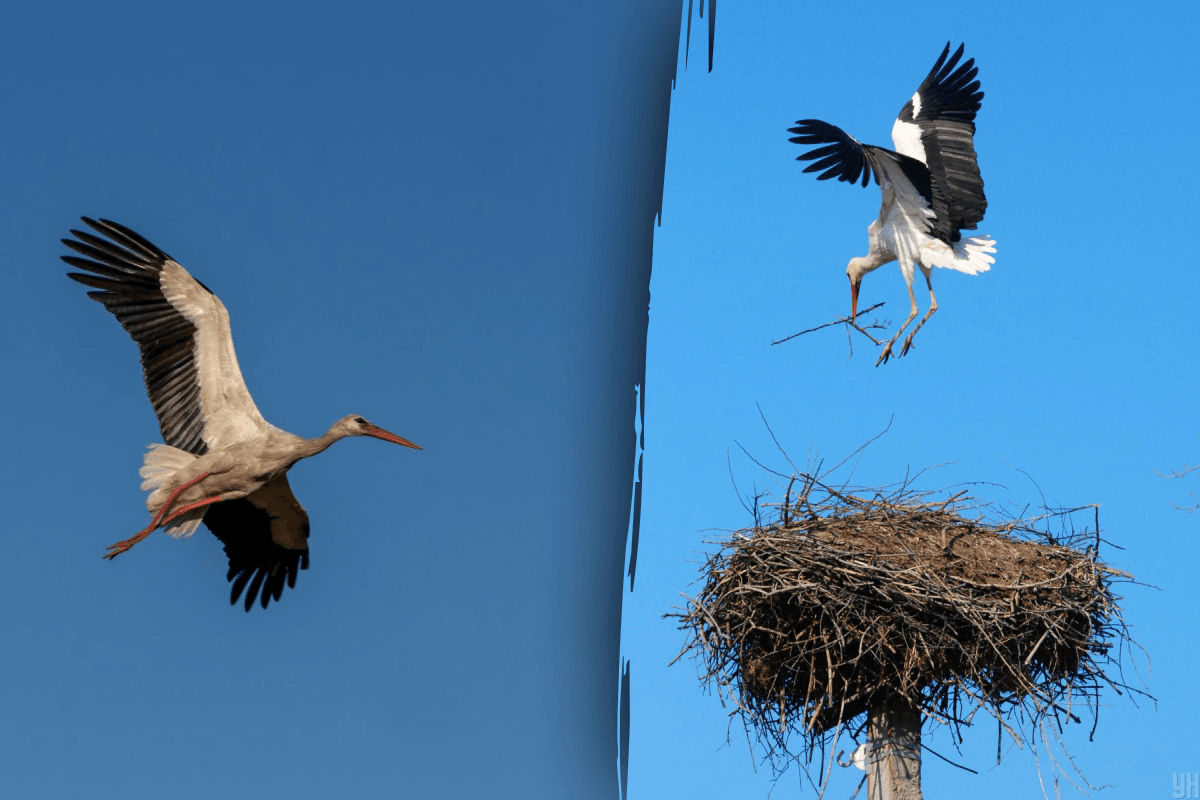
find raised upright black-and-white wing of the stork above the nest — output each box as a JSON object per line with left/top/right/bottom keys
{"left": 892, "top": 42, "right": 988, "bottom": 241}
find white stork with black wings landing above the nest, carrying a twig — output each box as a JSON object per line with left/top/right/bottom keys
{"left": 788, "top": 42, "right": 996, "bottom": 366}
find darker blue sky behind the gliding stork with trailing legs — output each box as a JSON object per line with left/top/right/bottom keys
{"left": 0, "top": 1, "right": 678, "bottom": 798}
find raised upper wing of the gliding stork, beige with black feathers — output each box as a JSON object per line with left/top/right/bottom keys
{"left": 62, "top": 217, "right": 271, "bottom": 456}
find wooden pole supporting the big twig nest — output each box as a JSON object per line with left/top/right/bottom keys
{"left": 866, "top": 694, "right": 922, "bottom": 800}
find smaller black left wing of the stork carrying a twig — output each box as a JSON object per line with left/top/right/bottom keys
{"left": 787, "top": 120, "right": 934, "bottom": 211}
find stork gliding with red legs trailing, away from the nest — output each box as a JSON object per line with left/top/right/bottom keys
{"left": 62, "top": 217, "right": 420, "bottom": 612}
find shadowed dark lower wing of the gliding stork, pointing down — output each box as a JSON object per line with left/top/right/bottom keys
{"left": 204, "top": 473, "right": 308, "bottom": 612}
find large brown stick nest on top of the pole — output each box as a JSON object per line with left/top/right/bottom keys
{"left": 668, "top": 475, "right": 1147, "bottom": 777}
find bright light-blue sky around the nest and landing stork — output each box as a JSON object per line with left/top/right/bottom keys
{"left": 622, "top": 2, "right": 1200, "bottom": 799}
